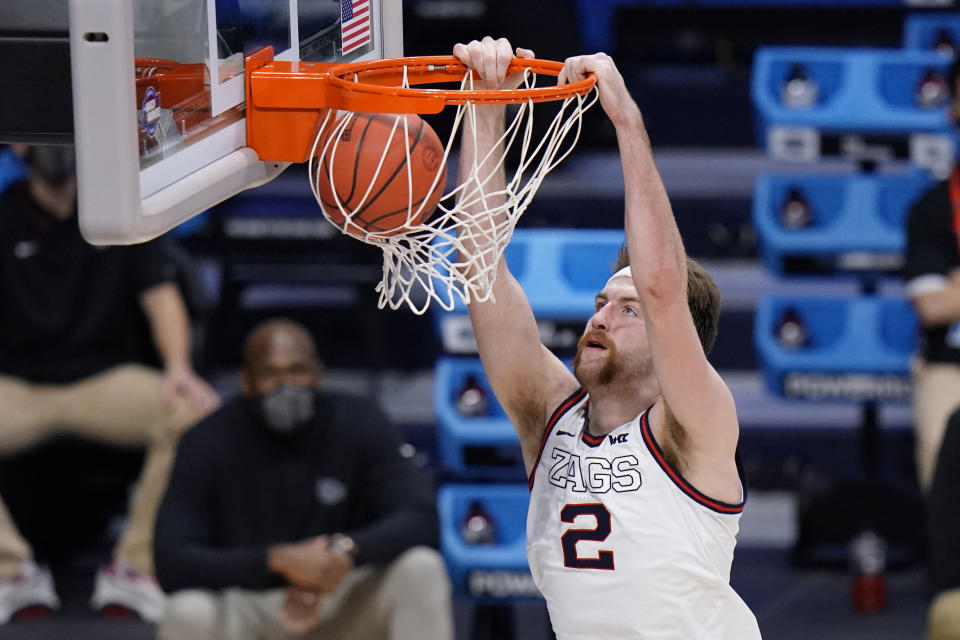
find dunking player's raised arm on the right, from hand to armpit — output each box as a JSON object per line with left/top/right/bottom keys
{"left": 561, "top": 53, "right": 739, "bottom": 501}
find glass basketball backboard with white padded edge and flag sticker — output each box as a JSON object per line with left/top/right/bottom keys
{"left": 70, "top": 0, "right": 403, "bottom": 244}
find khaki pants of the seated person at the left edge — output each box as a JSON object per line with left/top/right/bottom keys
{"left": 0, "top": 365, "right": 200, "bottom": 579}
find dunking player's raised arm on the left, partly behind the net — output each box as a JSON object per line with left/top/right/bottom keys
{"left": 453, "top": 37, "right": 578, "bottom": 472}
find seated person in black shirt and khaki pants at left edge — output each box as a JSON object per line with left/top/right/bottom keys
{"left": 0, "top": 145, "right": 218, "bottom": 622}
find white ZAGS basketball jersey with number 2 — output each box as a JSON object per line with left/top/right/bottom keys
{"left": 527, "top": 389, "right": 760, "bottom": 640}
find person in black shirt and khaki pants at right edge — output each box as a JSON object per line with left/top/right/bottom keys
{"left": 904, "top": 61, "right": 960, "bottom": 491}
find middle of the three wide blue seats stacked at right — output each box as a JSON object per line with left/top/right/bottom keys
{"left": 753, "top": 172, "right": 933, "bottom": 275}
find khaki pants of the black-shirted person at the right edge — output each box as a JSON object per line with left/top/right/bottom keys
{"left": 913, "top": 358, "right": 960, "bottom": 491}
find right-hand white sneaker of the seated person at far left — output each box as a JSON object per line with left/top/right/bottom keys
{"left": 90, "top": 560, "right": 167, "bottom": 622}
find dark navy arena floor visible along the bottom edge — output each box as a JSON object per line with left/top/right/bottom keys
{"left": 0, "top": 516, "right": 928, "bottom": 640}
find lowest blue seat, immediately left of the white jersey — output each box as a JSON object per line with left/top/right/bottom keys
{"left": 437, "top": 484, "right": 541, "bottom": 604}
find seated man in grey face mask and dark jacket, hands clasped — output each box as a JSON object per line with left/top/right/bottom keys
{"left": 154, "top": 319, "right": 453, "bottom": 640}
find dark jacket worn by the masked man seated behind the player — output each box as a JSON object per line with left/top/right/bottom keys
{"left": 154, "top": 393, "right": 438, "bottom": 591}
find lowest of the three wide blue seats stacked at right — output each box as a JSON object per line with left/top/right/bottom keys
{"left": 754, "top": 297, "right": 917, "bottom": 401}
